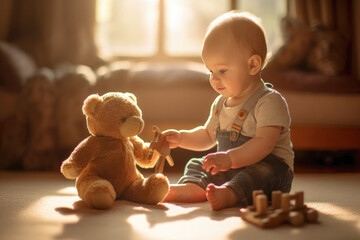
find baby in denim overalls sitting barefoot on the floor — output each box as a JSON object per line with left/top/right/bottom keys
{"left": 164, "top": 11, "right": 294, "bottom": 210}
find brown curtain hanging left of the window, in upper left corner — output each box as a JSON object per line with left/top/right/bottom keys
{"left": 5, "top": 0, "right": 100, "bottom": 67}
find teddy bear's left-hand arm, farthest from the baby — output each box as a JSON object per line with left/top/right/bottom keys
{"left": 60, "top": 136, "right": 95, "bottom": 179}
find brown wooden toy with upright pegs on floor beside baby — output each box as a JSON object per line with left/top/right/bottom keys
{"left": 240, "top": 190, "right": 319, "bottom": 228}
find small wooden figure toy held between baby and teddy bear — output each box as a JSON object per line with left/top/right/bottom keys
{"left": 149, "top": 126, "right": 174, "bottom": 173}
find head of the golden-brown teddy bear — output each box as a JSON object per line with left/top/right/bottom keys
{"left": 83, "top": 92, "right": 144, "bottom": 139}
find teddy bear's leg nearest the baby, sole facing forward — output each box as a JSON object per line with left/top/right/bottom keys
{"left": 122, "top": 173, "right": 169, "bottom": 204}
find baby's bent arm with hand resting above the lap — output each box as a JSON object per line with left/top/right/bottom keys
{"left": 203, "top": 126, "right": 281, "bottom": 174}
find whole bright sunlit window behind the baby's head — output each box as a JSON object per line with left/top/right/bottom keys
{"left": 96, "top": 0, "right": 286, "bottom": 60}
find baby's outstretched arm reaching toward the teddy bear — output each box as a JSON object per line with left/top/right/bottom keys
{"left": 163, "top": 126, "right": 216, "bottom": 151}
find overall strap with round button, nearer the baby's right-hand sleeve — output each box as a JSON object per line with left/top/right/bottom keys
{"left": 230, "top": 84, "right": 271, "bottom": 141}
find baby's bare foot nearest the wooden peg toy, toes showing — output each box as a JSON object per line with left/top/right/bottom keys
{"left": 206, "top": 184, "right": 237, "bottom": 211}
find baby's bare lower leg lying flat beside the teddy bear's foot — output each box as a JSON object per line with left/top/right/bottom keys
{"left": 163, "top": 183, "right": 206, "bottom": 203}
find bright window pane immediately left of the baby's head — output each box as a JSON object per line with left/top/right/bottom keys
{"left": 165, "top": 0, "right": 230, "bottom": 56}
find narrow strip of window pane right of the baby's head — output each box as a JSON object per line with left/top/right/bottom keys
{"left": 237, "top": 0, "right": 286, "bottom": 53}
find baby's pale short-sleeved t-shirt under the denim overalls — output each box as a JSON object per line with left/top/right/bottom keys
{"left": 205, "top": 89, "right": 294, "bottom": 170}
